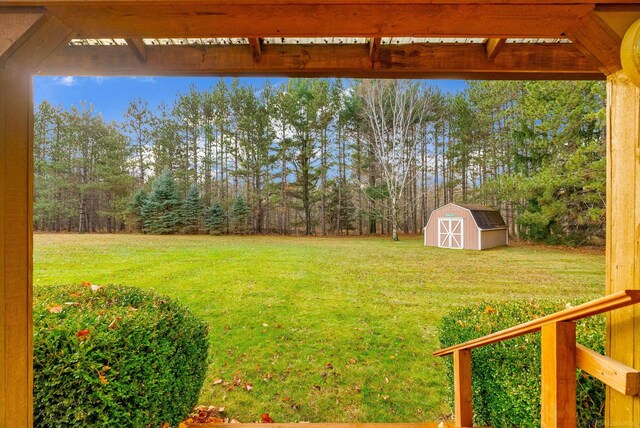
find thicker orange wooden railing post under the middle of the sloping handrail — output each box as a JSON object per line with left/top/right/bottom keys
{"left": 541, "top": 321, "right": 576, "bottom": 428}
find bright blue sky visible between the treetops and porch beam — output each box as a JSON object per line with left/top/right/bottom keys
{"left": 34, "top": 76, "right": 465, "bottom": 121}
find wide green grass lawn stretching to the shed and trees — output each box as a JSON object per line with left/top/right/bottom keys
{"left": 34, "top": 234, "right": 605, "bottom": 422}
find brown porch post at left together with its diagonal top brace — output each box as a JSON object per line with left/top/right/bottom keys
{"left": 0, "top": 12, "right": 71, "bottom": 428}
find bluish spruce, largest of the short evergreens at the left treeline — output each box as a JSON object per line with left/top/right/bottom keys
{"left": 141, "top": 171, "right": 182, "bottom": 234}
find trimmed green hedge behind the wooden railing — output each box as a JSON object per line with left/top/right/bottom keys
{"left": 439, "top": 301, "right": 605, "bottom": 428}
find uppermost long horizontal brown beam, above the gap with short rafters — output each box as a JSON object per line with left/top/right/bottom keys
{"left": 42, "top": 0, "right": 594, "bottom": 38}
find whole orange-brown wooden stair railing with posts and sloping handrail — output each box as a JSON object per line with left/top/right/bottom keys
{"left": 434, "top": 290, "right": 640, "bottom": 427}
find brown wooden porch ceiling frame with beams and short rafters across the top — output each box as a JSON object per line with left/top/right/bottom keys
{"left": 0, "top": 0, "right": 640, "bottom": 79}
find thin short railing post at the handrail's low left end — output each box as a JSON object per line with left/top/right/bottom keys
{"left": 453, "top": 349, "right": 473, "bottom": 427}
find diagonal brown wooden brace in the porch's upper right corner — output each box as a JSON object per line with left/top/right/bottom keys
{"left": 566, "top": 12, "right": 622, "bottom": 74}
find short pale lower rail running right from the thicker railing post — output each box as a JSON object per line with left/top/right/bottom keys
{"left": 576, "top": 345, "right": 640, "bottom": 395}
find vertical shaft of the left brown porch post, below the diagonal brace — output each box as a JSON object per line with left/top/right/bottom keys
{"left": 0, "top": 64, "right": 33, "bottom": 427}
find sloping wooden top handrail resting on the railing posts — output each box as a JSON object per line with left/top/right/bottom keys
{"left": 433, "top": 290, "right": 640, "bottom": 357}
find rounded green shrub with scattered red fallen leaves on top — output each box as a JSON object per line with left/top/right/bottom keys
{"left": 33, "top": 284, "right": 208, "bottom": 427}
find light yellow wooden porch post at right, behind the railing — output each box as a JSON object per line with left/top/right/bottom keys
{"left": 605, "top": 72, "right": 640, "bottom": 427}
